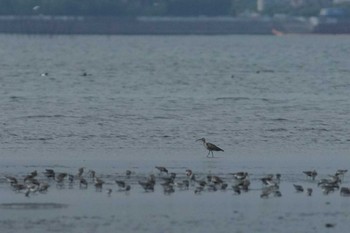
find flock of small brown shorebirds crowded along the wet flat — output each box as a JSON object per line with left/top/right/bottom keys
{"left": 0, "top": 166, "right": 350, "bottom": 198}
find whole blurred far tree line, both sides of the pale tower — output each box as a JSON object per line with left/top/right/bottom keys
{"left": 0, "top": 0, "right": 348, "bottom": 17}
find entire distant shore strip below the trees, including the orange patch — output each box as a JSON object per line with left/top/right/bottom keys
{"left": 0, "top": 15, "right": 350, "bottom": 35}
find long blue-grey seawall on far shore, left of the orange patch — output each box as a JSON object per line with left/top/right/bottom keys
{"left": 0, "top": 16, "right": 273, "bottom": 35}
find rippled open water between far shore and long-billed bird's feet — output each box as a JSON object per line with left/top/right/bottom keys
{"left": 0, "top": 33, "right": 350, "bottom": 151}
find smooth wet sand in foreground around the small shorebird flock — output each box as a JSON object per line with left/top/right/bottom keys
{"left": 0, "top": 150, "right": 350, "bottom": 233}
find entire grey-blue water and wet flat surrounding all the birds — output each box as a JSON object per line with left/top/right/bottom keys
{"left": 0, "top": 35, "right": 350, "bottom": 232}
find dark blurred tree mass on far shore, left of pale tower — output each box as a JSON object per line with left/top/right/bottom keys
{"left": 0, "top": 0, "right": 238, "bottom": 16}
